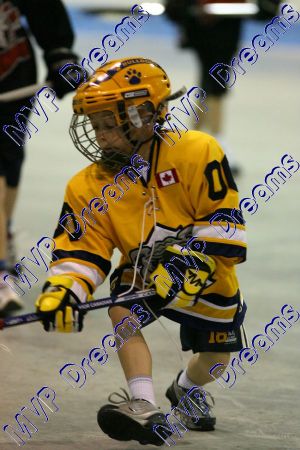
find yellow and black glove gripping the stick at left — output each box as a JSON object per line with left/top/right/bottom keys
{"left": 35, "top": 275, "right": 91, "bottom": 333}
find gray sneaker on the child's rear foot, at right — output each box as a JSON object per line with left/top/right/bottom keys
{"left": 166, "top": 371, "right": 216, "bottom": 431}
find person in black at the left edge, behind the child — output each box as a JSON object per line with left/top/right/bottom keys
{"left": 0, "top": 0, "right": 77, "bottom": 316}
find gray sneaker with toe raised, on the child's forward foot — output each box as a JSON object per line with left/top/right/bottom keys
{"left": 97, "top": 388, "right": 171, "bottom": 446}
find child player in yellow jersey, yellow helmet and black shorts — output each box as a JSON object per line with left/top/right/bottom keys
{"left": 36, "top": 57, "right": 246, "bottom": 445}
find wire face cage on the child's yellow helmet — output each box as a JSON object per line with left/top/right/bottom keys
{"left": 69, "top": 102, "right": 157, "bottom": 171}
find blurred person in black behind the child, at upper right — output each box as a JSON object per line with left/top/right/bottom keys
{"left": 166, "top": 0, "right": 279, "bottom": 175}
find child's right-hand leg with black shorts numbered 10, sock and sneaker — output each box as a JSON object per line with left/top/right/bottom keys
{"left": 166, "top": 325, "right": 247, "bottom": 431}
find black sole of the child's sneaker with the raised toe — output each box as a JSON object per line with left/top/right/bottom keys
{"left": 97, "top": 406, "right": 168, "bottom": 446}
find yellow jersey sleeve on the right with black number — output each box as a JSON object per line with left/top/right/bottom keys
{"left": 189, "top": 137, "right": 246, "bottom": 265}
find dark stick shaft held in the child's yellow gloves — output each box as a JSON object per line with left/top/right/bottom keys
{"left": 0, "top": 289, "right": 155, "bottom": 330}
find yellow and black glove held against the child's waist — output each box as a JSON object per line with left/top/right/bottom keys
{"left": 149, "top": 244, "right": 216, "bottom": 306}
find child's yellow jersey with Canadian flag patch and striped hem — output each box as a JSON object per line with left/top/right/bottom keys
{"left": 50, "top": 131, "right": 246, "bottom": 330}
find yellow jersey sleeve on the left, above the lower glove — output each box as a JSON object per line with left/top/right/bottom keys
{"left": 50, "top": 184, "right": 115, "bottom": 293}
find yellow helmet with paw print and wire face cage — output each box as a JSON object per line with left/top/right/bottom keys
{"left": 70, "top": 57, "right": 171, "bottom": 168}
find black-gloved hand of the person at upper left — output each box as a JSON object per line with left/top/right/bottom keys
{"left": 45, "top": 48, "right": 78, "bottom": 98}
